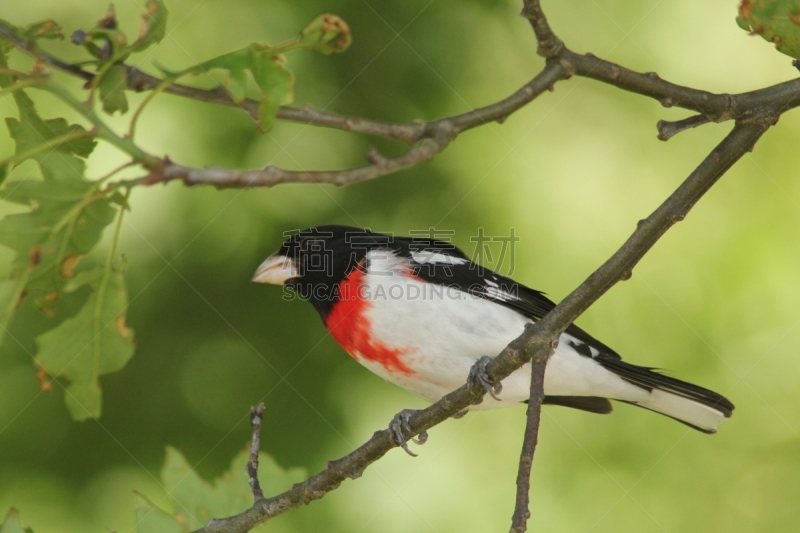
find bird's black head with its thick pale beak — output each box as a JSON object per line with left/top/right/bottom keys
{"left": 253, "top": 226, "right": 387, "bottom": 317}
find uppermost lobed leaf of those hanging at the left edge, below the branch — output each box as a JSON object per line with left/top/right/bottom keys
{"left": 6, "top": 91, "right": 97, "bottom": 180}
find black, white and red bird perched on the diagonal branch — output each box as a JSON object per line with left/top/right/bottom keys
{"left": 253, "top": 226, "right": 733, "bottom": 453}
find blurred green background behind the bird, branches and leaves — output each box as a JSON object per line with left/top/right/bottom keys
{"left": 0, "top": 0, "right": 800, "bottom": 533}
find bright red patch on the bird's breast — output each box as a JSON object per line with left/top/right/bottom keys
{"left": 325, "top": 269, "right": 413, "bottom": 375}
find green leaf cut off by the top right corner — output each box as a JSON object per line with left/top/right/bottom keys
{"left": 736, "top": 0, "right": 800, "bottom": 59}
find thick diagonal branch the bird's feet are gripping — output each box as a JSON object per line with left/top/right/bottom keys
{"left": 192, "top": 123, "right": 769, "bottom": 533}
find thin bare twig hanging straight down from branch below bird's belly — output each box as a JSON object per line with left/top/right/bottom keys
{"left": 510, "top": 346, "right": 553, "bottom": 533}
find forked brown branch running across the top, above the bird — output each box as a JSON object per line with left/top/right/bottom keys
{"left": 0, "top": 12, "right": 800, "bottom": 188}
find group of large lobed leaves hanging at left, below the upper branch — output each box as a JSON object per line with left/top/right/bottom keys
{"left": 0, "top": 78, "right": 133, "bottom": 420}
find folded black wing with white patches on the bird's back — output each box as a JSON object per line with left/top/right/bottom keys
{"left": 395, "top": 238, "right": 621, "bottom": 359}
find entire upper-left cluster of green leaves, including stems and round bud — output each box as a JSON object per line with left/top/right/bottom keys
{"left": 0, "top": 4, "right": 351, "bottom": 420}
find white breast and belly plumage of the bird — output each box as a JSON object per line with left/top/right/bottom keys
{"left": 361, "top": 252, "right": 641, "bottom": 408}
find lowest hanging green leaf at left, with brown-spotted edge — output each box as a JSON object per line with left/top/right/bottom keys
{"left": 34, "top": 264, "right": 133, "bottom": 420}
